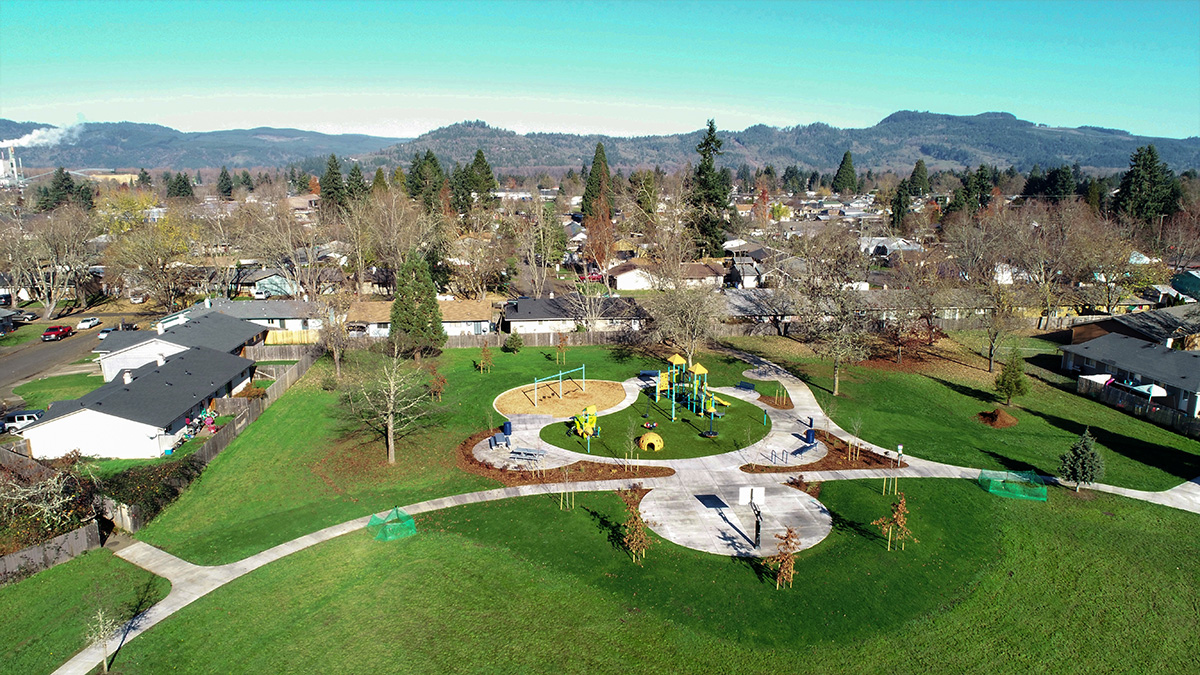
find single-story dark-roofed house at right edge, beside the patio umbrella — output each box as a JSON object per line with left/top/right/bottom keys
{"left": 1058, "top": 333, "right": 1200, "bottom": 418}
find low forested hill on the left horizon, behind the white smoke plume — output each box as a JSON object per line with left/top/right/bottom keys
{"left": 0, "top": 120, "right": 403, "bottom": 169}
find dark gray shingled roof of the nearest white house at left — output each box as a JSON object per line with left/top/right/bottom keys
{"left": 37, "top": 347, "right": 254, "bottom": 428}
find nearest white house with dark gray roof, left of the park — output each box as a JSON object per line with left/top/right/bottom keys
{"left": 20, "top": 347, "right": 254, "bottom": 459}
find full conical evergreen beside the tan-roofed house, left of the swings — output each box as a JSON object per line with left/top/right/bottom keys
{"left": 389, "top": 255, "right": 446, "bottom": 354}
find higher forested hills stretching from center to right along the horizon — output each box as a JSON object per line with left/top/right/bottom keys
{"left": 380, "top": 110, "right": 1200, "bottom": 173}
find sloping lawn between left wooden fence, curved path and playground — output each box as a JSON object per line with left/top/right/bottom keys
{"left": 137, "top": 347, "right": 768, "bottom": 565}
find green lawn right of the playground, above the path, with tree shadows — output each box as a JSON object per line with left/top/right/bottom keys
{"left": 730, "top": 338, "right": 1200, "bottom": 490}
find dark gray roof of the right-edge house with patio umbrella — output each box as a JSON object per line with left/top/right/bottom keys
{"left": 1058, "top": 333, "right": 1200, "bottom": 392}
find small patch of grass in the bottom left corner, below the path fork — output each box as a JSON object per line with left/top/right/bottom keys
{"left": 0, "top": 549, "right": 170, "bottom": 675}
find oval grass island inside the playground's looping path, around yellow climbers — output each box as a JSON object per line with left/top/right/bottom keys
{"left": 541, "top": 386, "right": 770, "bottom": 459}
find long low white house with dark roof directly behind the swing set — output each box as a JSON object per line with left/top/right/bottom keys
{"left": 502, "top": 294, "right": 649, "bottom": 333}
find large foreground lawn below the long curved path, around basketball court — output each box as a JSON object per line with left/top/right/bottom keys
{"left": 98, "top": 479, "right": 1200, "bottom": 674}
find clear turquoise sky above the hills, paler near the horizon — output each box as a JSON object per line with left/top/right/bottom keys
{"left": 0, "top": 0, "right": 1200, "bottom": 137}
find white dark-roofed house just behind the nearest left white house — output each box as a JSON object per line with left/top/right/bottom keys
{"left": 92, "top": 312, "right": 266, "bottom": 382}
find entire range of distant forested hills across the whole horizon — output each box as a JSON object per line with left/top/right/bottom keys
{"left": 0, "top": 110, "right": 1200, "bottom": 174}
